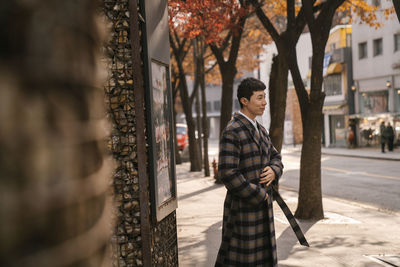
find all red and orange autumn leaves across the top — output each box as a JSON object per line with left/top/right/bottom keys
{"left": 169, "top": 0, "right": 394, "bottom": 84}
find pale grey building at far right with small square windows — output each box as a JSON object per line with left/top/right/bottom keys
{"left": 350, "top": 1, "right": 400, "bottom": 146}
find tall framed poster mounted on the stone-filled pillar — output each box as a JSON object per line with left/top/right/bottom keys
{"left": 148, "top": 60, "right": 177, "bottom": 221}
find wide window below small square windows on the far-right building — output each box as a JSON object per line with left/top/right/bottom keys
{"left": 360, "top": 91, "right": 388, "bottom": 114}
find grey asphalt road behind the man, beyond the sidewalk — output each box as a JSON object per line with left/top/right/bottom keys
{"left": 280, "top": 152, "right": 400, "bottom": 212}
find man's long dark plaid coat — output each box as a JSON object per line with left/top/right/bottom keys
{"left": 215, "top": 113, "right": 283, "bottom": 267}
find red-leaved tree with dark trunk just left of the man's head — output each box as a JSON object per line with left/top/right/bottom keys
{"left": 170, "top": 0, "right": 248, "bottom": 138}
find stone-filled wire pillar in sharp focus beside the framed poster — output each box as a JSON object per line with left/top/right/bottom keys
{"left": 103, "top": 0, "right": 178, "bottom": 267}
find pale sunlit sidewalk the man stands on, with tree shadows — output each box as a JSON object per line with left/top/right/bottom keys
{"left": 176, "top": 162, "right": 400, "bottom": 267}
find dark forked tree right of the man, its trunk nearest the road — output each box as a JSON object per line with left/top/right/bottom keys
{"left": 291, "top": 0, "right": 391, "bottom": 219}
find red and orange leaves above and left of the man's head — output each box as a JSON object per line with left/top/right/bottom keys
{"left": 169, "top": 0, "right": 276, "bottom": 84}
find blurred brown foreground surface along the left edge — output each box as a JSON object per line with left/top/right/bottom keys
{"left": 0, "top": 0, "right": 112, "bottom": 267}
